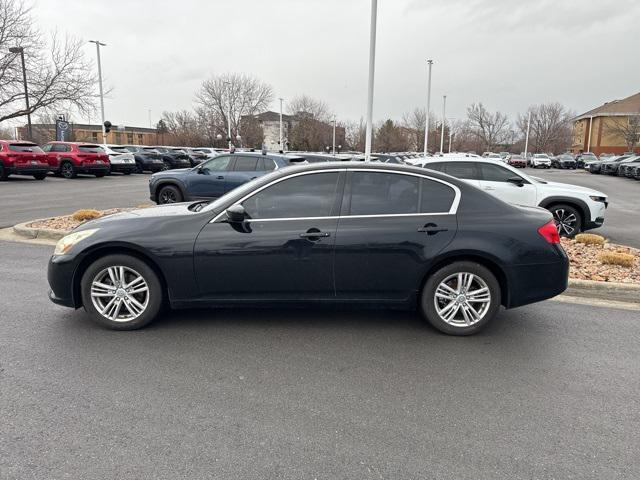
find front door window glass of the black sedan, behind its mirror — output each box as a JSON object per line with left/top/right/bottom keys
{"left": 242, "top": 172, "right": 338, "bottom": 219}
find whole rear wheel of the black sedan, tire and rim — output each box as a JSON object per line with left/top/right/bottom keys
{"left": 420, "top": 261, "right": 500, "bottom": 335}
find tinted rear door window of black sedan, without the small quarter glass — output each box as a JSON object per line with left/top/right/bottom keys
{"left": 349, "top": 172, "right": 420, "bottom": 215}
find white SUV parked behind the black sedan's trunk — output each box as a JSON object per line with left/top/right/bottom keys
{"left": 419, "top": 156, "right": 608, "bottom": 237}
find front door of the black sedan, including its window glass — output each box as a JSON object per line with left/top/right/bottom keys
{"left": 194, "top": 171, "right": 344, "bottom": 300}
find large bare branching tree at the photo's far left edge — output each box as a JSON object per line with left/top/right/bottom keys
{"left": 0, "top": 0, "right": 96, "bottom": 122}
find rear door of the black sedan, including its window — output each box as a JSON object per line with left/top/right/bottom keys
{"left": 334, "top": 170, "right": 460, "bottom": 301}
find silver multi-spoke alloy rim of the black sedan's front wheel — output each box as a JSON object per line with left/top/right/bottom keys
{"left": 91, "top": 266, "right": 149, "bottom": 322}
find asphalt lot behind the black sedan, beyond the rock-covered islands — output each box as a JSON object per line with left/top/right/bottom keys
{"left": 0, "top": 168, "right": 640, "bottom": 248}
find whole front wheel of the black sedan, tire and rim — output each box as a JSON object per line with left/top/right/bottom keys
{"left": 81, "top": 255, "right": 163, "bottom": 330}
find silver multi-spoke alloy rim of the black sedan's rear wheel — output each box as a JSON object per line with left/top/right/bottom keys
{"left": 433, "top": 272, "right": 491, "bottom": 327}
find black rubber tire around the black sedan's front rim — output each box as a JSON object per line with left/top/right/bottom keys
{"left": 80, "top": 254, "right": 164, "bottom": 330}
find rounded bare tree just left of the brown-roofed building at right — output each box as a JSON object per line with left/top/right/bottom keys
{"left": 516, "top": 102, "right": 574, "bottom": 153}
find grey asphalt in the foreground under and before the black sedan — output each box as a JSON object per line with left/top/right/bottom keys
{"left": 0, "top": 242, "right": 640, "bottom": 479}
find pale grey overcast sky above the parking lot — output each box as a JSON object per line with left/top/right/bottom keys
{"left": 34, "top": 0, "right": 640, "bottom": 126}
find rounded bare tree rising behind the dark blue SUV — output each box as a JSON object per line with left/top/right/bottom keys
{"left": 196, "top": 73, "right": 273, "bottom": 145}
